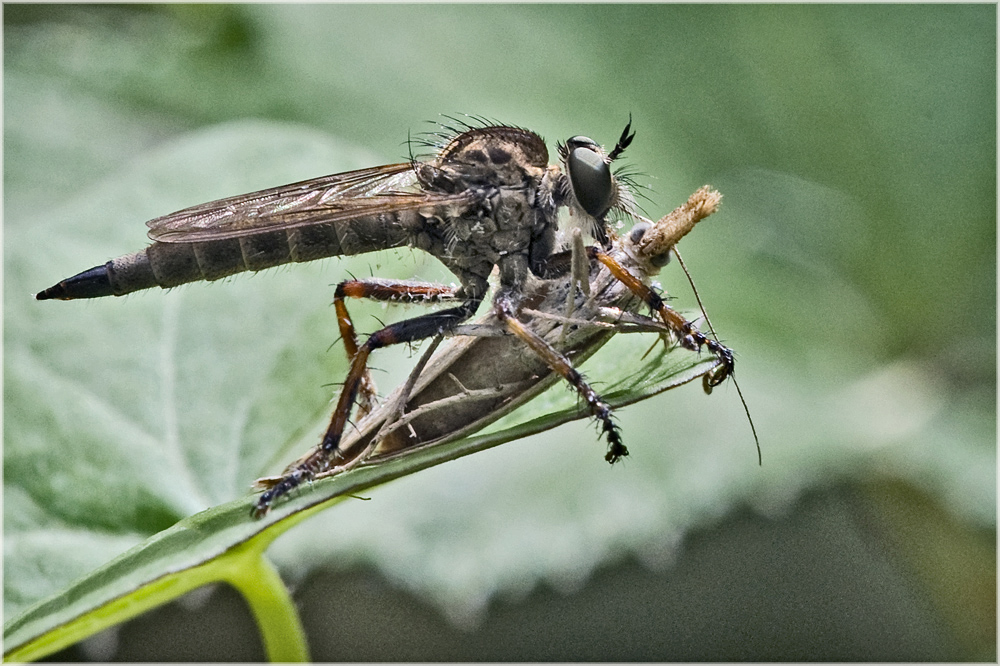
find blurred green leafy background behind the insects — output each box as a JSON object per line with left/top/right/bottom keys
{"left": 3, "top": 5, "right": 997, "bottom": 661}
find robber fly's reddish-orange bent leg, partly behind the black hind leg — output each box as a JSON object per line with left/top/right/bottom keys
{"left": 333, "top": 279, "right": 455, "bottom": 416}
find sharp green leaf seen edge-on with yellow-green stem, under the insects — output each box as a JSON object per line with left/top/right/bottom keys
{"left": 4, "top": 324, "right": 716, "bottom": 661}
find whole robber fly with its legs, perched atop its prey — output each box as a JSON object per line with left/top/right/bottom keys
{"left": 36, "top": 119, "right": 748, "bottom": 515}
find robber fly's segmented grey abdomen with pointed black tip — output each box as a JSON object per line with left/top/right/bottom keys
{"left": 35, "top": 213, "right": 416, "bottom": 301}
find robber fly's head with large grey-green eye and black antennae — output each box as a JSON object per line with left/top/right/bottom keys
{"left": 559, "top": 119, "right": 635, "bottom": 249}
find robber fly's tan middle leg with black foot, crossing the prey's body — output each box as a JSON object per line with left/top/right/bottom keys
{"left": 494, "top": 294, "right": 628, "bottom": 464}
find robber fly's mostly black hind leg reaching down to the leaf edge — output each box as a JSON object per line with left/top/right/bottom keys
{"left": 253, "top": 288, "right": 482, "bottom": 518}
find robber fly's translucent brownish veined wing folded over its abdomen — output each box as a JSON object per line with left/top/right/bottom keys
{"left": 146, "top": 162, "right": 473, "bottom": 243}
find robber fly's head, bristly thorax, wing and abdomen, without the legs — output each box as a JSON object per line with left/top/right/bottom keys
{"left": 36, "top": 122, "right": 635, "bottom": 302}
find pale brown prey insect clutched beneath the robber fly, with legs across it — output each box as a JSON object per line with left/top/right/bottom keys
{"left": 255, "top": 187, "right": 756, "bottom": 512}
